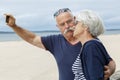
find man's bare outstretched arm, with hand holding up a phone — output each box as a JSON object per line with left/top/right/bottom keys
{"left": 5, "top": 14, "right": 45, "bottom": 49}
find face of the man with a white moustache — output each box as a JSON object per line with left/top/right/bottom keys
{"left": 56, "top": 12, "right": 75, "bottom": 37}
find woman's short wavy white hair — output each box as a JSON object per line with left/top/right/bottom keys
{"left": 76, "top": 10, "right": 104, "bottom": 37}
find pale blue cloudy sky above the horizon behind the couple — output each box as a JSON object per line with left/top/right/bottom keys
{"left": 0, "top": 0, "right": 120, "bottom": 31}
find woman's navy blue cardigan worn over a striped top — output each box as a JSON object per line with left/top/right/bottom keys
{"left": 72, "top": 39, "right": 112, "bottom": 80}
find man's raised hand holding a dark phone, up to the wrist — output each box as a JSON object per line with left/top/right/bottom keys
{"left": 4, "top": 14, "right": 16, "bottom": 27}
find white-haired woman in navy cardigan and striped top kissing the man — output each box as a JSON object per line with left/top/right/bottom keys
{"left": 72, "top": 10, "right": 112, "bottom": 80}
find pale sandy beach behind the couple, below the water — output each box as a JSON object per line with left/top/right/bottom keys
{"left": 0, "top": 34, "right": 120, "bottom": 80}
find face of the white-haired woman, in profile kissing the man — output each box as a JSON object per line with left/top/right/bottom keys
{"left": 73, "top": 21, "right": 85, "bottom": 38}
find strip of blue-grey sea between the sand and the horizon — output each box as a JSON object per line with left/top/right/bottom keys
{"left": 0, "top": 29, "right": 120, "bottom": 42}
